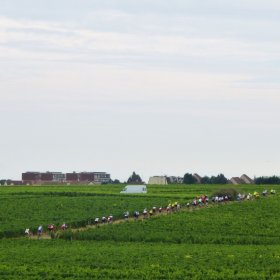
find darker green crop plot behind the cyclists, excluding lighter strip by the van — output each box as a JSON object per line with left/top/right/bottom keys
{"left": 0, "top": 192, "right": 172, "bottom": 237}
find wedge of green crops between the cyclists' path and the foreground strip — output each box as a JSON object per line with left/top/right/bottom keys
{"left": 61, "top": 197, "right": 280, "bottom": 245}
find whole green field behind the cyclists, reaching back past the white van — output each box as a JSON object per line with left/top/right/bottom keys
{"left": 0, "top": 186, "right": 201, "bottom": 237}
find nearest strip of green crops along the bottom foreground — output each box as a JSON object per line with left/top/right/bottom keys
{"left": 0, "top": 239, "right": 280, "bottom": 280}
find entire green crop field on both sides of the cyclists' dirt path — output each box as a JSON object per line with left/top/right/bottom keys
{"left": 0, "top": 185, "right": 280, "bottom": 279}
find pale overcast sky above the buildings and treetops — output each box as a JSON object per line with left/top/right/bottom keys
{"left": 0, "top": 0, "right": 280, "bottom": 180}
